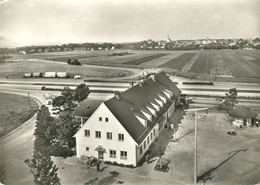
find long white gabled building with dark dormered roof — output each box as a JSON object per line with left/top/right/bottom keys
{"left": 75, "top": 72, "right": 181, "bottom": 166}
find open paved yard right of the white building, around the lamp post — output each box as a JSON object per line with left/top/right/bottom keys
{"left": 163, "top": 113, "right": 260, "bottom": 183}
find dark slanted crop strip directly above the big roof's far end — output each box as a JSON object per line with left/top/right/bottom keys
{"left": 161, "top": 52, "right": 196, "bottom": 70}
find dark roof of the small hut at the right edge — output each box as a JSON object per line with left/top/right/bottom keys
{"left": 227, "top": 107, "right": 257, "bottom": 118}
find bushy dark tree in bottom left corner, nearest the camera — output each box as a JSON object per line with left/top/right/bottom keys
{"left": 24, "top": 151, "right": 60, "bottom": 185}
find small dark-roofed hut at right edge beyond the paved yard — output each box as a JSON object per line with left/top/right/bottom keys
{"left": 227, "top": 107, "right": 257, "bottom": 127}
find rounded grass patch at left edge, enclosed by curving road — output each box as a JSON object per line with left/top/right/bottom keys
{"left": 0, "top": 93, "right": 38, "bottom": 137}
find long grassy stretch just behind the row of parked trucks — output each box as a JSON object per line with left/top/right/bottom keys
{"left": 0, "top": 60, "right": 132, "bottom": 78}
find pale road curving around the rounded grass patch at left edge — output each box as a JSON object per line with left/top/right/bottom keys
{"left": 0, "top": 88, "right": 53, "bottom": 185}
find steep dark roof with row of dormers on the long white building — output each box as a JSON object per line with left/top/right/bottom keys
{"left": 104, "top": 72, "right": 181, "bottom": 144}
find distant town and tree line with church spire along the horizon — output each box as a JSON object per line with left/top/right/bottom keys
{"left": 0, "top": 36, "right": 260, "bottom": 54}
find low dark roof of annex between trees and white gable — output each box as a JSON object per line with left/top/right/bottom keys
{"left": 72, "top": 99, "right": 103, "bottom": 117}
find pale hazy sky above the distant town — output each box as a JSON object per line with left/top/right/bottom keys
{"left": 0, "top": 0, "right": 260, "bottom": 44}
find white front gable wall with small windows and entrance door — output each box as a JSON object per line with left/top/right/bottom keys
{"left": 75, "top": 103, "right": 136, "bottom": 165}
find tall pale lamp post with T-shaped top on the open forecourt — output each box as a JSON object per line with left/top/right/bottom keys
{"left": 184, "top": 108, "right": 208, "bottom": 184}
